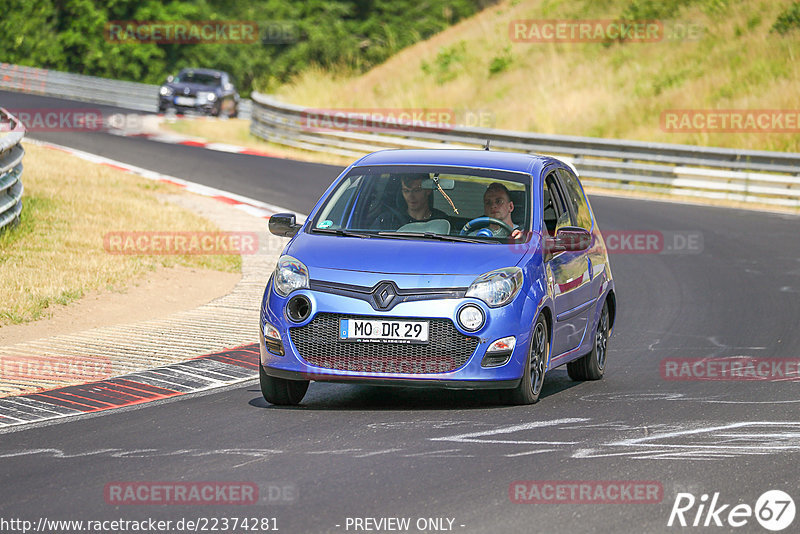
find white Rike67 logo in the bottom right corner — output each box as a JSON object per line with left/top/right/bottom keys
{"left": 667, "top": 490, "right": 795, "bottom": 532}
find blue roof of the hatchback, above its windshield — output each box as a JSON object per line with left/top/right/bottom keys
{"left": 353, "top": 149, "right": 563, "bottom": 174}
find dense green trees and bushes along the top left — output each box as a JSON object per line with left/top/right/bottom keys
{"left": 0, "top": 0, "right": 494, "bottom": 96}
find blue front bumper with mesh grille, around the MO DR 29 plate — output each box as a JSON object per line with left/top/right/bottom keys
{"left": 259, "top": 281, "right": 535, "bottom": 389}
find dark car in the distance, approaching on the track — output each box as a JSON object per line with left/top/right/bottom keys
{"left": 158, "top": 69, "right": 239, "bottom": 117}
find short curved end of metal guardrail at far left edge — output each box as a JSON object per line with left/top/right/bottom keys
{"left": 0, "top": 108, "right": 25, "bottom": 231}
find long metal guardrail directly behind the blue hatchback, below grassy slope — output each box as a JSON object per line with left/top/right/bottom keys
{"left": 250, "top": 92, "right": 800, "bottom": 209}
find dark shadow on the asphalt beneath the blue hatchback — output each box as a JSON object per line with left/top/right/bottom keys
{"left": 248, "top": 369, "right": 581, "bottom": 411}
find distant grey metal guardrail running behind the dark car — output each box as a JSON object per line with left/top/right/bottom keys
{"left": 0, "top": 63, "right": 252, "bottom": 119}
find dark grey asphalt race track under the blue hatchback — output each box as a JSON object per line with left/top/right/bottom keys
{"left": 0, "top": 92, "right": 800, "bottom": 533}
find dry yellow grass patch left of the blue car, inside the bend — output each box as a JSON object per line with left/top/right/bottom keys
{"left": 0, "top": 144, "right": 241, "bottom": 326}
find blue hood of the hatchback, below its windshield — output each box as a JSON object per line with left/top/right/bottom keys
{"left": 286, "top": 232, "right": 528, "bottom": 278}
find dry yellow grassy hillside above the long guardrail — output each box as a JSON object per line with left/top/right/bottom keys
{"left": 279, "top": 0, "right": 800, "bottom": 152}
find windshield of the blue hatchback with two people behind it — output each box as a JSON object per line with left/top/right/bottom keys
{"left": 311, "top": 166, "right": 530, "bottom": 242}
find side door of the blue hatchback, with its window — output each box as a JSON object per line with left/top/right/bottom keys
{"left": 542, "top": 167, "right": 592, "bottom": 359}
